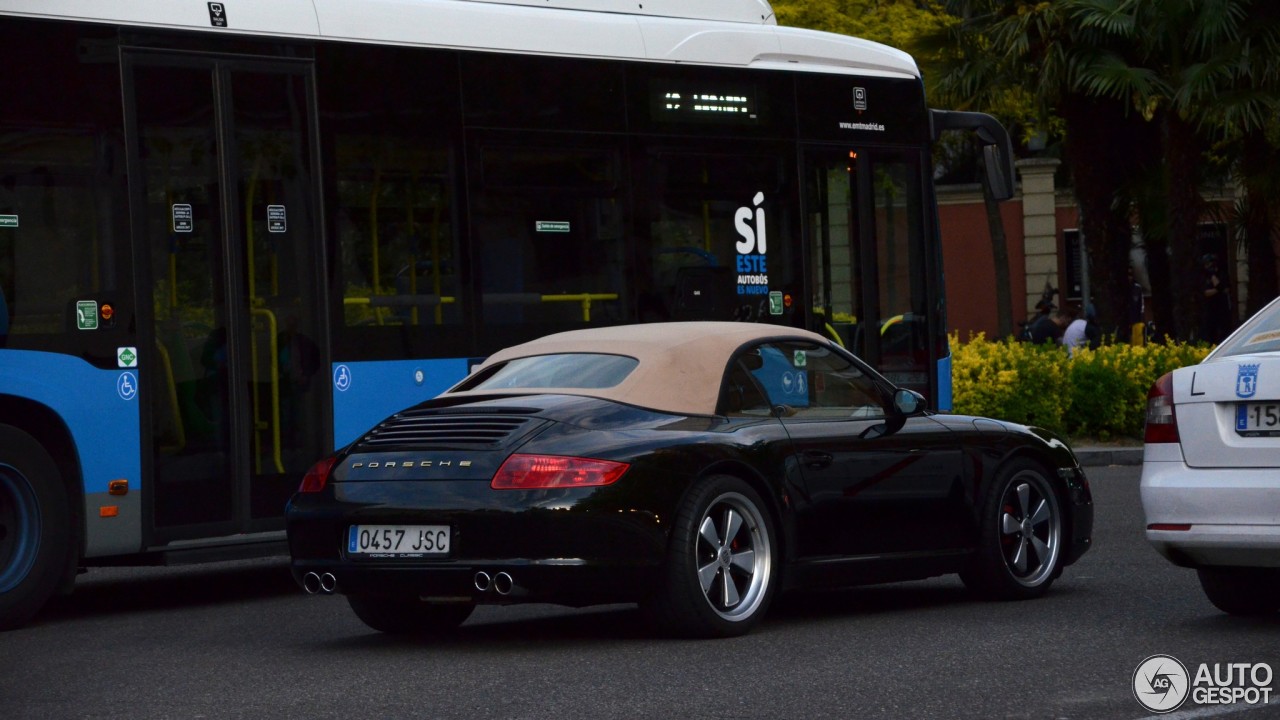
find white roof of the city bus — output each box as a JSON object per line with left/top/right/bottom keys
{"left": 0, "top": 0, "right": 919, "bottom": 78}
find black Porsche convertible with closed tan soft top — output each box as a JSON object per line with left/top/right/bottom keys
{"left": 287, "top": 323, "right": 1093, "bottom": 637}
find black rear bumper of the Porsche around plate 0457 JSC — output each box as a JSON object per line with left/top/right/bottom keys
{"left": 285, "top": 483, "right": 667, "bottom": 605}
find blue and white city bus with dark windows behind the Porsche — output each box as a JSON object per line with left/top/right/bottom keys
{"left": 0, "top": 0, "right": 1011, "bottom": 628}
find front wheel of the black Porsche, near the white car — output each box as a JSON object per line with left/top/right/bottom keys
{"left": 960, "top": 459, "right": 1066, "bottom": 600}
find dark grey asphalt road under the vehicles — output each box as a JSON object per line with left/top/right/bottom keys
{"left": 0, "top": 466, "right": 1280, "bottom": 720}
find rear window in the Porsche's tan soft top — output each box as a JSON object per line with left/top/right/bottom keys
{"left": 453, "top": 352, "right": 640, "bottom": 392}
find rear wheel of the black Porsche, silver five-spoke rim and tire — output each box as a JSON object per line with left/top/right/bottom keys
{"left": 644, "top": 475, "right": 777, "bottom": 638}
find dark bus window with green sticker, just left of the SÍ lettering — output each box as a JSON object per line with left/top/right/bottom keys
{"left": 468, "top": 132, "right": 627, "bottom": 352}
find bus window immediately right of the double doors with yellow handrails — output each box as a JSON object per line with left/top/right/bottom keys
{"left": 317, "top": 45, "right": 472, "bottom": 360}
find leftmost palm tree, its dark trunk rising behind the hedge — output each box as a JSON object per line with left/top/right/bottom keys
{"left": 934, "top": 0, "right": 1153, "bottom": 335}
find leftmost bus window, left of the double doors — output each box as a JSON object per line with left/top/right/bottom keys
{"left": 0, "top": 23, "right": 133, "bottom": 356}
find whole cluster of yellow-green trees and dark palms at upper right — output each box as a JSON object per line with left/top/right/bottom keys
{"left": 776, "top": 0, "right": 1280, "bottom": 337}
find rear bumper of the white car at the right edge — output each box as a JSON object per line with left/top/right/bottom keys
{"left": 1140, "top": 445, "right": 1280, "bottom": 568}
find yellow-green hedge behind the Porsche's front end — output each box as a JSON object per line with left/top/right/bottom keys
{"left": 951, "top": 333, "right": 1211, "bottom": 441}
